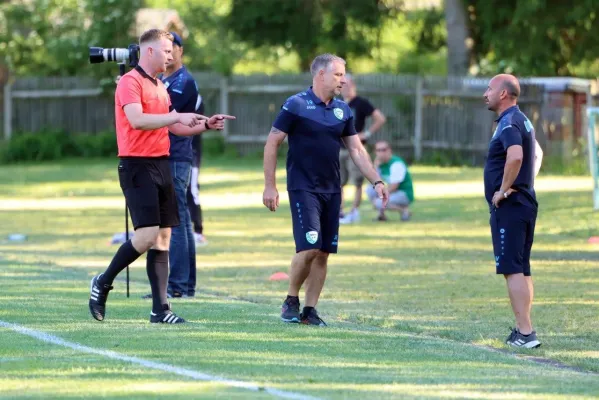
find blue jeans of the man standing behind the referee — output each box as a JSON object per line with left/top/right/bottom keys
{"left": 168, "top": 160, "right": 196, "bottom": 296}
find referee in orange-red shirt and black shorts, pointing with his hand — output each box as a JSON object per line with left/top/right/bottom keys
{"left": 89, "top": 29, "right": 235, "bottom": 324}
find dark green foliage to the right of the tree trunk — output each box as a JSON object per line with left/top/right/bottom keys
{"left": 465, "top": 0, "right": 599, "bottom": 76}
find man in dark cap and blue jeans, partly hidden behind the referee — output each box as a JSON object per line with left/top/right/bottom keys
{"left": 161, "top": 32, "right": 201, "bottom": 297}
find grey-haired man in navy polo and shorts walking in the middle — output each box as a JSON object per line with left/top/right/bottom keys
{"left": 263, "top": 54, "right": 389, "bottom": 326}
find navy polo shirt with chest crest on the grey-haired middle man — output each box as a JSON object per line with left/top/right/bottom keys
{"left": 273, "top": 87, "right": 356, "bottom": 193}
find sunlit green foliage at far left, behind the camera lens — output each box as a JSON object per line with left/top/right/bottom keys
{"left": 0, "top": 0, "right": 142, "bottom": 76}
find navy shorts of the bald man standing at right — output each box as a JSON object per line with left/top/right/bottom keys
{"left": 490, "top": 200, "right": 537, "bottom": 276}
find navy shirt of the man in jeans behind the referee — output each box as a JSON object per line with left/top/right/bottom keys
{"left": 161, "top": 67, "right": 202, "bottom": 162}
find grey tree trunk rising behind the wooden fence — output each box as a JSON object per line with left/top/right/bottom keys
{"left": 445, "top": 0, "right": 470, "bottom": 76}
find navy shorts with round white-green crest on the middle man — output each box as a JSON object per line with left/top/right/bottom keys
{"left": 289, "top": 190, "right": 341, "bottom": 253}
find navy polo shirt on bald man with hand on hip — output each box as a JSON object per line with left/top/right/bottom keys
{"left": 484, "top": 106, "right": 538, "bottom": 209}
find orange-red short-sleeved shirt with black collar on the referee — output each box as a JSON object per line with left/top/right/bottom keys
{"left": 114, "top": 66, "right": 171, "bottom": 157}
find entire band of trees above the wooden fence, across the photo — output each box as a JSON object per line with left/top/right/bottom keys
{"left": 0, "top": 0, "right": 599, "bottom": 81}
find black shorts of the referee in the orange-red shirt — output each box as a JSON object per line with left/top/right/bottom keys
{"left": 118, "top": 157, "right": 179, "bottom": 229}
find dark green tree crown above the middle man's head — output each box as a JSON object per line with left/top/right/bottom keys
{"left": 227, "top": 0, "right": 391, "bottom": 71}
